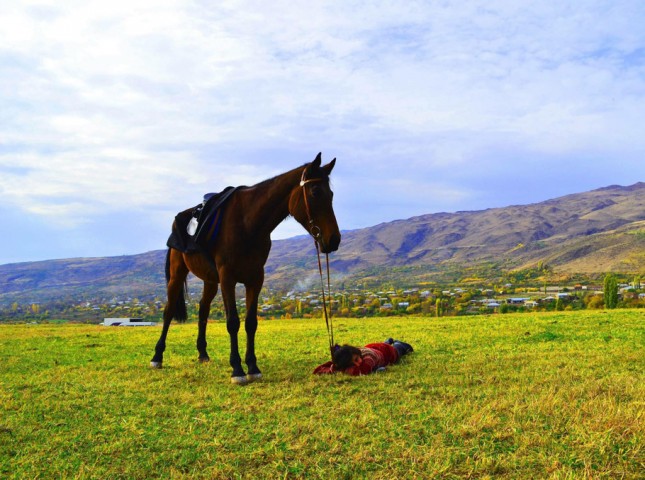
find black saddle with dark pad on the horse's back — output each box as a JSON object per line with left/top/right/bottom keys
{"left": 166, "top": 187, "right": 237, "bottom": 253}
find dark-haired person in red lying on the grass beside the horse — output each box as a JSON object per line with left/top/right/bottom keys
{"left": 314, "top": 338, "right": 414, "bottom": 375}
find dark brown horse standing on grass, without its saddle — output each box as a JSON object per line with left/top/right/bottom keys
{"left": 150, "top": 153, "right": 340, "bottom": 384}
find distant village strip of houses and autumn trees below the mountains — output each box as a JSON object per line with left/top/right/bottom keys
{"left": 0, "top": 280, "right": 645, "bottom": 323}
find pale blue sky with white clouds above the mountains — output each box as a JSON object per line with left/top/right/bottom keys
{"left": 0, "top": 0, "right": 645, "bottom": 264}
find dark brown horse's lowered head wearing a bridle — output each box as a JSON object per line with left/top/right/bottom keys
{"left": 289, "top": 153, "right": 340, "bottom": 253}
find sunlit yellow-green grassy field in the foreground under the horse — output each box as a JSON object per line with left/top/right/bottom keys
{"left": 0, "top": 310, "right": 645, "bottom": 479}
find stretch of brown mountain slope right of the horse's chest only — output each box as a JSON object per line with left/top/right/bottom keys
{"left": 267, "top": 182, "right": 645, "bottom": 281}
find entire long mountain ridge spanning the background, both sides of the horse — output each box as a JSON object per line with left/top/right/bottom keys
{"left": 0, "top": 182, "right": 645, "bottom": 302}
